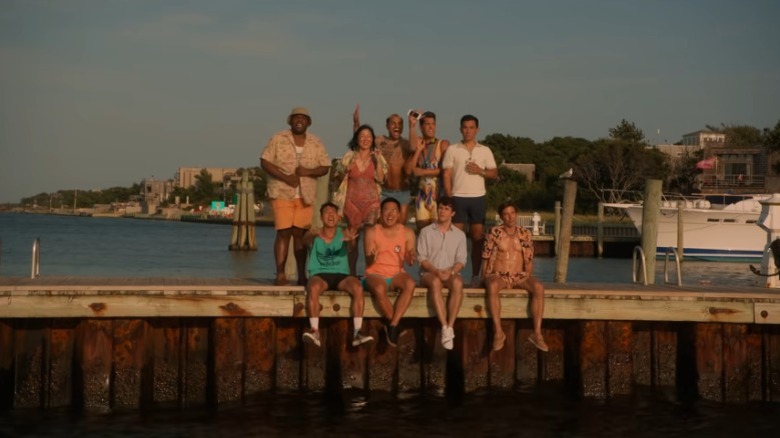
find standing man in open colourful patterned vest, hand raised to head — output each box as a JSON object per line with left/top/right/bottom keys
{"left": 405, "top": 111, "right": 450, "bottom": 231}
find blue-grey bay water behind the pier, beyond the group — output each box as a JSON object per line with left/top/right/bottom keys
{"left": 0, "top": 213, "right": 759, "bottom": 286}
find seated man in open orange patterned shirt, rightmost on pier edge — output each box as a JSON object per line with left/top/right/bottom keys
{"left": 482, "top": 202, "right": 547, "bottom": 351}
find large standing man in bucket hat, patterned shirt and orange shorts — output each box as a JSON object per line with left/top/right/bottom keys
{"left": 260, "top": 107, "right": 330, "bottom": 285}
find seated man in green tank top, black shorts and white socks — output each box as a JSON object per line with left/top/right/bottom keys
{"left": 303, "top": 202, "right": 374, "bottom": 347}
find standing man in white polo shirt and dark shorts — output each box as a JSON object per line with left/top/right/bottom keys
{"left": 442, "top": 114, "right": 498, "bottom": 287}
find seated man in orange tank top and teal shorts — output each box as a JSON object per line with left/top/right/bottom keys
{"left": 363, "top": 198, "right": 415, "bottom": 346}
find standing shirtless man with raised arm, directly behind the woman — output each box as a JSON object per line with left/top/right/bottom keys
{"left": 352, "top": 105, "right": 414, "bottom": 224}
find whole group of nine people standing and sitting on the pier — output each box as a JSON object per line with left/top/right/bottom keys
{"left": 260, "top": 107, "right": 547, "bottom": 351}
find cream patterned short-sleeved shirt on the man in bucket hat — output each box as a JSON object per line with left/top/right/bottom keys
{"left": 260, "top": 129, "right": 330, "bottom": 205}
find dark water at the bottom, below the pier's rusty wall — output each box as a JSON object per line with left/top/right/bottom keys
{"left": 0, "top": 388, "right": 780, "bottom": 437}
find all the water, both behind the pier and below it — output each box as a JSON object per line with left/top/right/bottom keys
{"left": 0, "top": 214, "right": 780, "bottom": 437}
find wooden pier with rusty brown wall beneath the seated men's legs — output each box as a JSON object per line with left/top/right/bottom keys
{"left": 0, "top": 277, "right": 780, "bottom": 410}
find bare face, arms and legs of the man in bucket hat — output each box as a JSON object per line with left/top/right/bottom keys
{"left": 260, "top": 114, "right": 330, "bottom": 286}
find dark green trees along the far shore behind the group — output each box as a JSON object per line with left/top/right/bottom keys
{"left": 16, "top": 119, "right": 780, "bottom": 213}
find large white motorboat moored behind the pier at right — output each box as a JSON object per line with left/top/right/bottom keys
{"left": 604, "top": 194, "right": 769, "bottom": 262}
